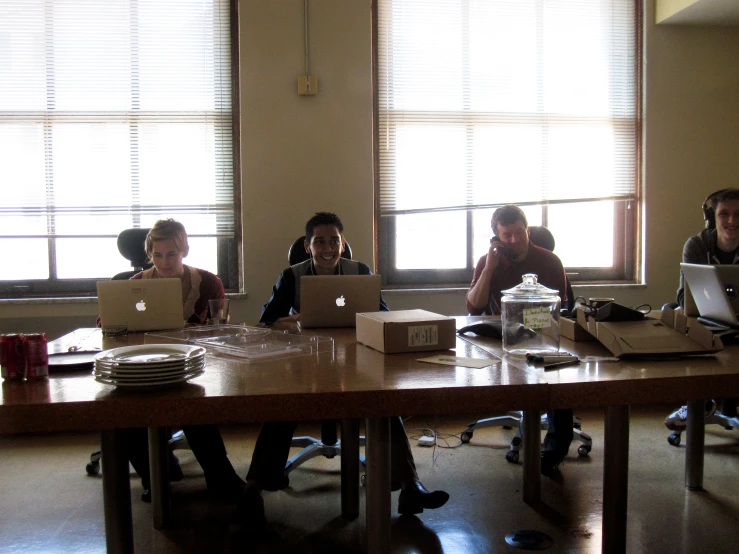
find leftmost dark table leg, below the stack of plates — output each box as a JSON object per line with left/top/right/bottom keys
{"left": 100, "top": 429, "right": 133, "bottom": 554}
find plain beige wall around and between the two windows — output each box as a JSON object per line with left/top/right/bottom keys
{"left": 0, "top": 0, "right": 739, "bottom": 336}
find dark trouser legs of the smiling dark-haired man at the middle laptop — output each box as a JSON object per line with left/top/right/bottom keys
{"left": 246, "top": 417, "right": 418, "bottom": 491}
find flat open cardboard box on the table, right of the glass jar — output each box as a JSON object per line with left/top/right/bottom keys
{"left": 588, "top": 310, "right": 724, "bottom": 358}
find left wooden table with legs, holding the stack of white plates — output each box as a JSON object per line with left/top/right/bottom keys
{"left": 0, "top": 329, "right": 548, "bottom": 553}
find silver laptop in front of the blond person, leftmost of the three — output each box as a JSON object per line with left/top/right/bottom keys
{"left": 97, "top": 278, "right": 185, "bottom": 331}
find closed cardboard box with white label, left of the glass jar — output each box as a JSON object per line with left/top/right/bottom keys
{"left": 357, "top": 310, "right": 457, "bottom": 354}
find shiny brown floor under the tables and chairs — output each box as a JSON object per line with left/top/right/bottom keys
{"left": 0, "top": 406, "right": 739, "bottom": 554}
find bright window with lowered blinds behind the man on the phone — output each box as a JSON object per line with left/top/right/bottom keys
{"left": 375, "top": 0, "right": 641, "bottom": 286}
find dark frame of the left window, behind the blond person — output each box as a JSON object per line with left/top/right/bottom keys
{"left": 0, "top": 0, "right": 244, "bottom": 298}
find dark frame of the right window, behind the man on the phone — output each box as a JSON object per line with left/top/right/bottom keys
{"left": 372, "top": 0, "right": 645, "bottom": 289}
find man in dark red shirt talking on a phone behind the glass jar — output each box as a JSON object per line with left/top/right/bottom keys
{"left": 467, "top": 205, "right": 573, "bottom": 475}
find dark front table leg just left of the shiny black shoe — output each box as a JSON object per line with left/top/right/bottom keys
{"left": 365, "top": 417, "right": 390, "bottom": 554}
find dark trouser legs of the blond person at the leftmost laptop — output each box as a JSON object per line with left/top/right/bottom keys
{"left": 125, "top": 425, "right": 238, "bottom": 489}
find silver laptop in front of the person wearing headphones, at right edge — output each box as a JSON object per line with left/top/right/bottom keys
{"left": 680, "top": 263, "right": 739, "bottom": 328}
